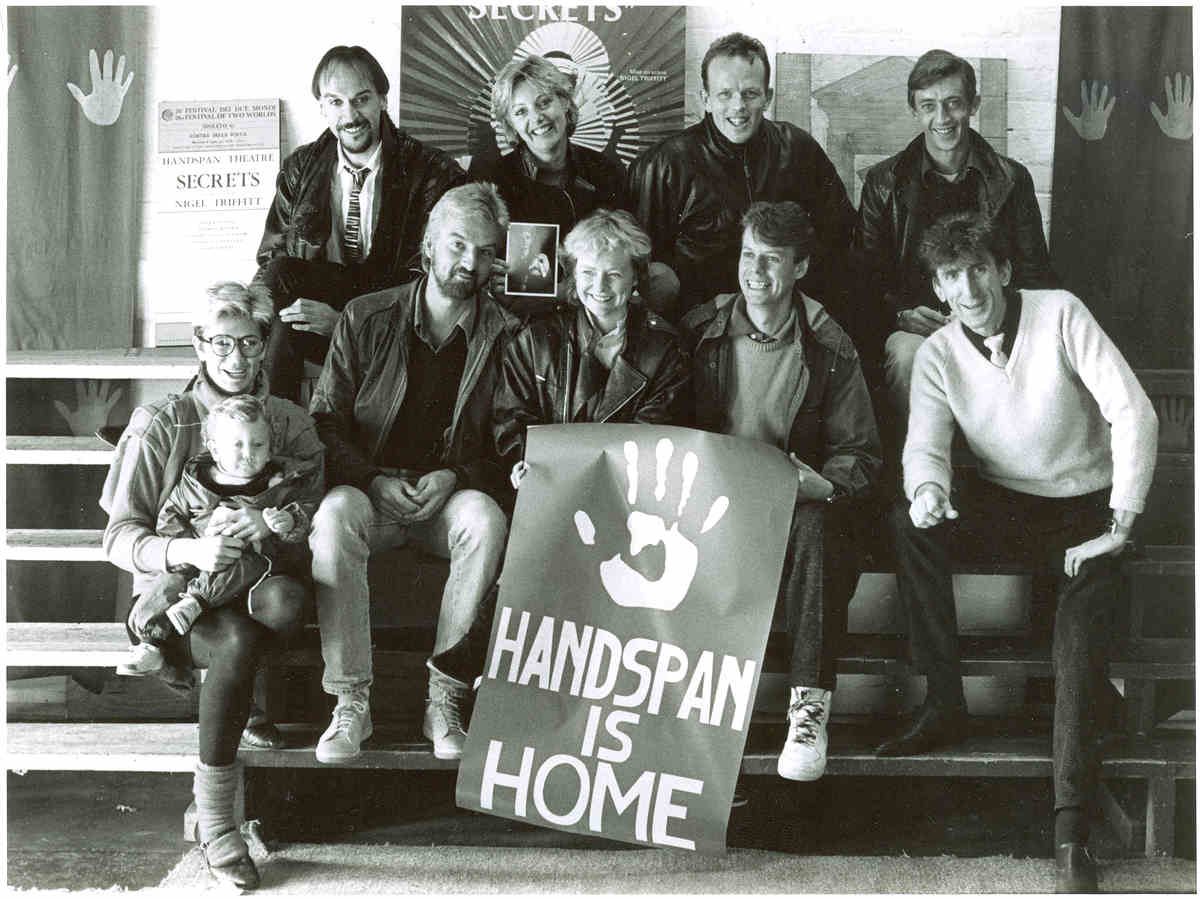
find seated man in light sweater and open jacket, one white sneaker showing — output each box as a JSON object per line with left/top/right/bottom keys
{"left": 683, "top": 202, "right": 882, "bottom": 780}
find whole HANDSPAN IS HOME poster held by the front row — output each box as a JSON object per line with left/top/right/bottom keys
{"left": 457, "top": 424, "right": 796, "bottom": 854}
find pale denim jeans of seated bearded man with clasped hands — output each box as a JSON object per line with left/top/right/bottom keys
{"left": 308, "top": 486, "right": 508, "bottom": 695}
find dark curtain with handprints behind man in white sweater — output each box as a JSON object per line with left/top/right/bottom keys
{"left": 1050, "top": 7, "right": 1193, "bottom": 369}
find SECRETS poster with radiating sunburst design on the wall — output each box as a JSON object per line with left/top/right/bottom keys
{"left": 400, "top": 4, "right": 686, "bottom": 168}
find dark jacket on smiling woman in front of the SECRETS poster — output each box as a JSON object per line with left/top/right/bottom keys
{"left": 467, "top": 144, "right": 625, "bottom": 236}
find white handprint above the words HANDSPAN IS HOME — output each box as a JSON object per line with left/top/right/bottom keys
{"left": 575, "top": 437, "right": 730, "bottom": 611}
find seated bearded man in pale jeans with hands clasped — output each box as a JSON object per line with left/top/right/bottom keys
{"left": 310, "top": 184, "right": 517, "bottom": 764}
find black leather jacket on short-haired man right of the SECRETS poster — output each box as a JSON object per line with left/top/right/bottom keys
{"left": 625, "top": 115, "right": 854, "bottom": 310}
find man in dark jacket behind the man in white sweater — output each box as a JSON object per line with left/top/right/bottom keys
{"left": 854, "top": 50, "right": 1058, "bottom": 424}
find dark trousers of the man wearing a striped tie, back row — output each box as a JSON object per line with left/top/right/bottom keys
{"left": 254, "top": 256, "right": 379, "bottom": 402}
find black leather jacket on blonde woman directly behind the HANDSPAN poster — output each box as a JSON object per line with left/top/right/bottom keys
{"left": 494, "top": 304, "right": 691, "bottom": 471}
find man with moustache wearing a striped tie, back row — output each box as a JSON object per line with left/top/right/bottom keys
{"left": 254, "top": 47, "right": 467, "bottom": 400}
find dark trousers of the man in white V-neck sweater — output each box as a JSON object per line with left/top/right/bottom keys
{"left": 892, "top": 478, "right": 1120, "bottom": 810}
